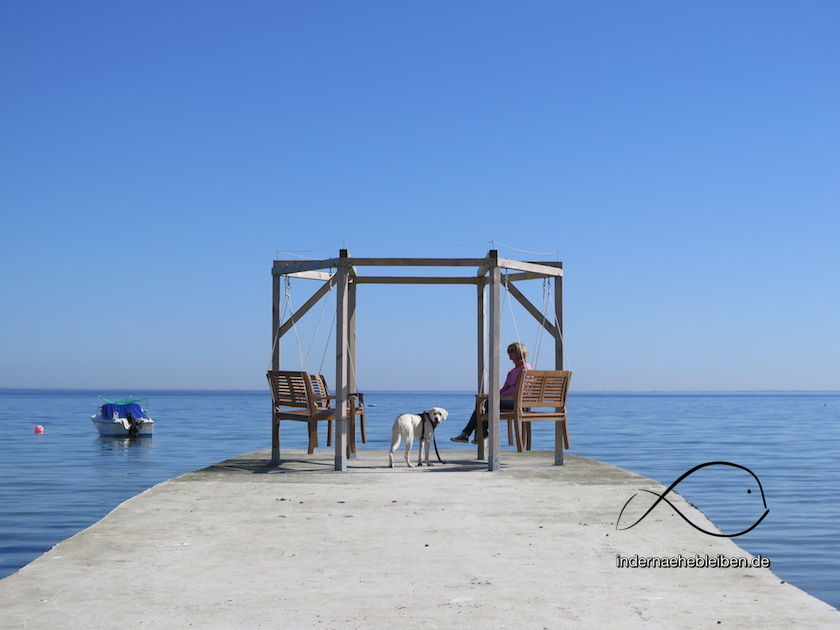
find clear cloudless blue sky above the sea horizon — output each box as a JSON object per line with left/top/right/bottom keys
{"left": 0, "top": 0, "right": 840, "bottom": 393}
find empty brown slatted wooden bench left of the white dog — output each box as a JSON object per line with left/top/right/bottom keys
{"left": 266, "top": 370, "right": 367, "bottom": 455}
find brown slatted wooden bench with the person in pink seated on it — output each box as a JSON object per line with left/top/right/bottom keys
{"left": 475, "top": 370, "right": 572, "bottom": 453}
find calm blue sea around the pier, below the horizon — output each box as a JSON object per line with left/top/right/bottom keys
{"left": 0, "top": 390, "right": 840, "bottom": 607}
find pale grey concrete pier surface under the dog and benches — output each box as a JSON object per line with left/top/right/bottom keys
{"left": 0, "top": 449, "right": 840, "bottom": 630}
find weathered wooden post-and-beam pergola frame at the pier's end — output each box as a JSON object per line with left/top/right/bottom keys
{"left": 271, "top": 249, "right": 563, "bottom": 471}
